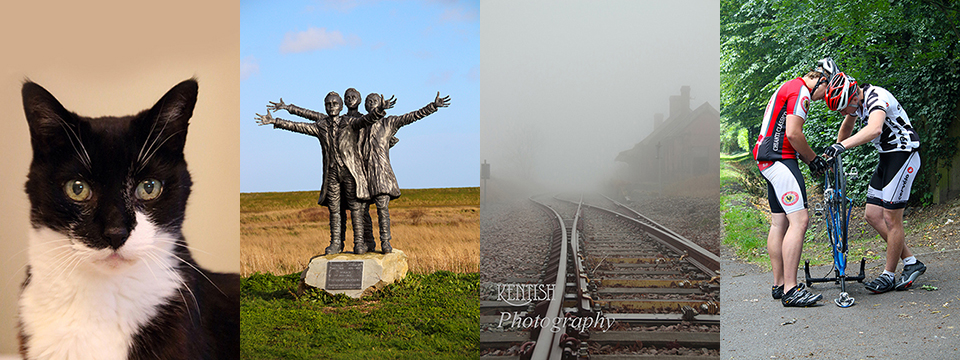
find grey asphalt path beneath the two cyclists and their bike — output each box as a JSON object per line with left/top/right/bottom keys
{"left": 720, "top": 250, "right": 960, "bottom": 359}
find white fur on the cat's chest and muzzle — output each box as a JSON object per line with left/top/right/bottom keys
{"left": 20, "top": 212, "right": 183, "bottom": 360}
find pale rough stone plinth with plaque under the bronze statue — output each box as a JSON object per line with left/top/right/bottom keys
{"left": 300, "top": 249, "right": 407, "bottom": 298}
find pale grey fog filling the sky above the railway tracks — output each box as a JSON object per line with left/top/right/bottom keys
{"left": 480, "top": 0, "right": 720, "bottom": 200}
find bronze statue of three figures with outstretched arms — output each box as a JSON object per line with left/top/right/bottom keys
{"left": 255, "top": 88, "right": 450, "bottom": 255}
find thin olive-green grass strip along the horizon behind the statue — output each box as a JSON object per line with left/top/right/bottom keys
{"left": 240, "top": 187, "right": 480, "bottom": 212}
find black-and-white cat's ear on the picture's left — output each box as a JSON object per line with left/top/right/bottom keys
{"left": 21, "top": 80, "right": 79, "bottom": 153}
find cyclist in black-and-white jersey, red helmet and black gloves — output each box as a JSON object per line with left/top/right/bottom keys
{"left": 824, "top": 72, "right": 927, "bottom": 294}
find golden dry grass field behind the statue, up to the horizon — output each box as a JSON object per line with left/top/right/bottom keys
{"left": 240, "top": 188, "right": 480, "bottom": 277}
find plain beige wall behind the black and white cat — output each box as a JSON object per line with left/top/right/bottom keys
{"left": 0, "top": 1, "right": 241, "bottom": 354}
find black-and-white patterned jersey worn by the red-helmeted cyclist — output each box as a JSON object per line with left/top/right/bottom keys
{"left": 854, "top": 84, "right": 920, "bottom": 153}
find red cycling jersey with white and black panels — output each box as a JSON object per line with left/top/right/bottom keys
{"left": 753, "top": 77, "right": 810, "bottom": 171}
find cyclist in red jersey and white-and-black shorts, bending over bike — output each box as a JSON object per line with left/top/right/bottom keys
{"left": 753, "top": 58, "right": 836, "bottom": 306}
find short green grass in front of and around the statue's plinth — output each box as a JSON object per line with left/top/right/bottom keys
{"left": 240, "top": 271, "right": 480, "bottom": 359}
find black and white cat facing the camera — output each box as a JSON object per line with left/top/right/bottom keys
{"left": 19, "top": 79, "right": 240, "bottom": 360}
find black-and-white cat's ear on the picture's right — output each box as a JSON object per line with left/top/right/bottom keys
{"left": 141, "top": 79, "right": 198, "bottom": 152}
